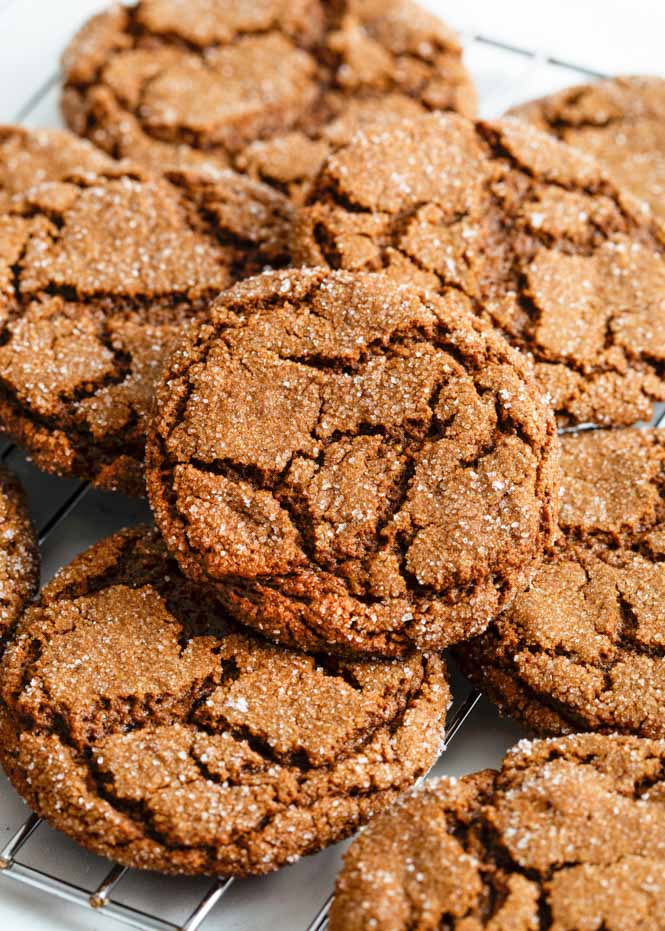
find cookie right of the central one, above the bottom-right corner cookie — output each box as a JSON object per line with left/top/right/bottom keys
{"left": 458, "top": 429, "right": 665, "bottom": 737}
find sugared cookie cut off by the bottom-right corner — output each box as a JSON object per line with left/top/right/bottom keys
{"left": 329, "top": 734, "right": 665, "bottom": 931}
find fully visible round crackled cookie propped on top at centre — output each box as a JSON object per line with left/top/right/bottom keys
{"left": 147, "top": 269, "right": 558, "bottom": 655}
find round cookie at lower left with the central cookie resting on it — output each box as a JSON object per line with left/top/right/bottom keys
{"left": 0, "top": 527, "right": 450, "bottom": 876}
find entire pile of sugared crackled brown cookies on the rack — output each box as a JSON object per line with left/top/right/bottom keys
{"left": 0, "top": 0, "right": 665, "bottom": 931}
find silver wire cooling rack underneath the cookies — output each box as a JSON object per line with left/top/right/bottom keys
{"left": 0, "top": 9, "right": 648, "bottom": 931}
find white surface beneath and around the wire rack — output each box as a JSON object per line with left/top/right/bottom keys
{"left": 0, "top": 0, "right": 665, "bottom": 931}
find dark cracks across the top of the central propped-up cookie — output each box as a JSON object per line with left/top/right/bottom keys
{"left": 151, "top": 272, "right": 551, "bottom": 643}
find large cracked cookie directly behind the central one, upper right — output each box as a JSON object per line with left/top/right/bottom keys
{"left": 294, "top": 114, "right": 665, "bottom": 425}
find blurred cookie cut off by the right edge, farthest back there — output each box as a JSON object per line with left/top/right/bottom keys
{"left": 511, "top": 77, "right": 665, "bottom": 222}
